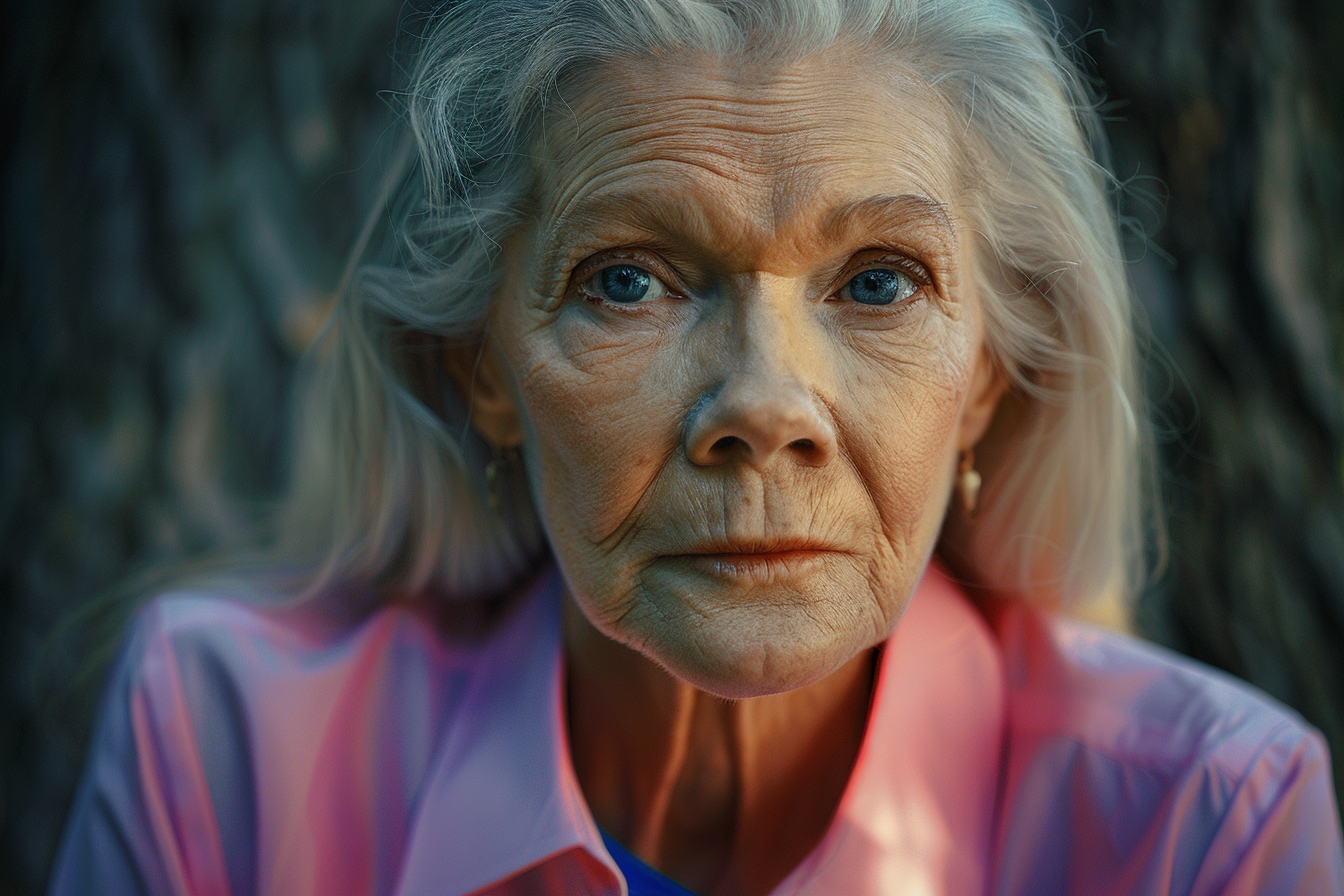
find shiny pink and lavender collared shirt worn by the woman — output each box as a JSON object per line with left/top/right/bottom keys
{"left": 51, "top": 567, "right": 1344, "bottom": 896}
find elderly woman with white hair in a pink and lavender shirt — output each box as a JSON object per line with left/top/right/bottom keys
{"left": 52, "top": 0, "right": 1344, "bottom": 896}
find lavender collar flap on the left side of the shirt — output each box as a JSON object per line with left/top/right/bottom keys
{"left": 398, "top": 571, "right": 622, "bottom": 896}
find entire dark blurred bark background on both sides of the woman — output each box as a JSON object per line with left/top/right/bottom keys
{"left": 0, "top": 0, "right": 1344, "bottom": 895}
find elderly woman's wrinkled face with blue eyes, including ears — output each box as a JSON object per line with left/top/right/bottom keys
{"left": 462, "top": 47, "right": 1000, "bottom": 697}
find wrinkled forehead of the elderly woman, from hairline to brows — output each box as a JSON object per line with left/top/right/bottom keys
{"left": 534, "top": 46, "right": 964, "bottom": 257}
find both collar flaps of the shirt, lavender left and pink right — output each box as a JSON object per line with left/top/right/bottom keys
{"left": 398, "top": 566, "right": 1004, "bottom": 896}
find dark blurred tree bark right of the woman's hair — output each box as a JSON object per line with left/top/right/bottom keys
{"left": 1056, "top": 0, "right": 1344, "bottom": 793}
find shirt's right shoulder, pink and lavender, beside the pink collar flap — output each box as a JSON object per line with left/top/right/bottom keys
{"left": 995, "top": 607, "right": 1340, "bottom": 893}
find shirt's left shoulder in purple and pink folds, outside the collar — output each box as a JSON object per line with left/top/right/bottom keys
{"left": 52, "top": 591, "right": 534, "bottom": 893}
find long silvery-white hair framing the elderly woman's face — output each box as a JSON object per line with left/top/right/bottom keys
{"left": 277, "top": 0, "right": 1146, "bottom": 609}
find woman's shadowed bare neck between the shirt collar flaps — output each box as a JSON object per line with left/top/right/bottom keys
{"left": 564, "top": 599, "right": 874, "bottom": 895}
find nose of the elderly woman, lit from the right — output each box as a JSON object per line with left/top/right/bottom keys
{"left": 685, "top": 291, "right": 836, "bottom": 469}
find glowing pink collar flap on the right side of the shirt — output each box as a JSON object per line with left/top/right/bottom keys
{"left": 775, "top": 563, "right": 1007, "bottom": 896}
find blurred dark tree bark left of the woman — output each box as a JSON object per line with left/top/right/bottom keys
{"left": 0, "top": 0, "right": 402, "bottom": 893}
